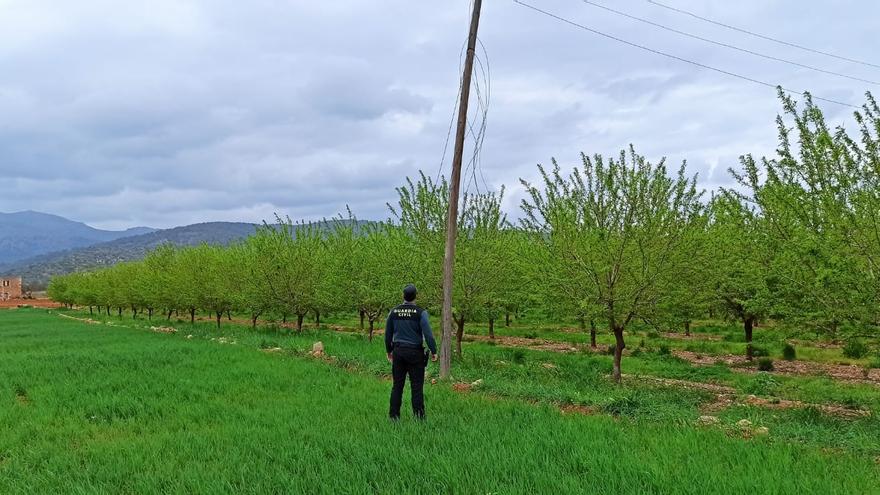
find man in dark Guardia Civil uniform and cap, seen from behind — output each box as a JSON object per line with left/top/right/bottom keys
{"left": 385, "top": 284, "right": 437, "bottom": 420}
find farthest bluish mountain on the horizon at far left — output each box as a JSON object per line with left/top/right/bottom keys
{"left": 0, "top": 211, "right": 155, "bottom": 266}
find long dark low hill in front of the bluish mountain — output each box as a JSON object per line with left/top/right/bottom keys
{"left": 0, "top": 222, "right": 257, "bottom": 290}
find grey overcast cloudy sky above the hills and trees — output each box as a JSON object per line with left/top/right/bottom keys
{"left": 0, "top": 0, "right": 880, "bottom": 229}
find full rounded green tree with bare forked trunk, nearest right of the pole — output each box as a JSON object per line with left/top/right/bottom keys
{"left": 522, "top": 147, "right": 702, "bottom": 382}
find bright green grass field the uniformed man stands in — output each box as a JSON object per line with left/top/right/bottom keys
{"left": 0, "top": 310, "right": 880, "bottom": 494}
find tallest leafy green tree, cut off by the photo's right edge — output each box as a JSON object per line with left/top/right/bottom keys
{"left": 734, "top": 91, "right": 880, "bottom": 335}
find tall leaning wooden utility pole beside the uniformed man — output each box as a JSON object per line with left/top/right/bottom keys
{"left": 440, "top": 0, "right": 483, "bottom": 379}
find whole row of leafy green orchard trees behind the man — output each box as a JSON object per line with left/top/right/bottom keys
{"left": 50, "top": 94, "right": 880, "bottom": 378}
